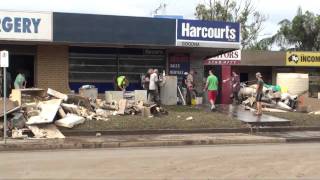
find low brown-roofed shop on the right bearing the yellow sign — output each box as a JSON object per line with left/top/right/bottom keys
{"left": 232, "top": 51, "right": 320, "bottom": 97}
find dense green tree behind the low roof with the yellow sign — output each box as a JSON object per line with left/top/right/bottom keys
{"left": 263, "top": 7, "right": 320, "bottom": 51}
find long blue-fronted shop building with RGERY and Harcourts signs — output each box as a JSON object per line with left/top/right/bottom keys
{"left": 0, "top": 11, "right": 240, "bottom": 102}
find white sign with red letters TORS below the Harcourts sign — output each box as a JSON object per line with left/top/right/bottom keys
{"left": 204, "top": 50, "right": 241, "bottom": 65}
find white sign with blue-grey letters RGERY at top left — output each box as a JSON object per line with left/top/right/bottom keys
{"left": 0, "top": 11, "right": 52, "bottom": 41}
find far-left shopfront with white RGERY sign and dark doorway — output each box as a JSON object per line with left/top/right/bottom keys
{"left": 0, "top": 11, "right": 53, "bottom": 90}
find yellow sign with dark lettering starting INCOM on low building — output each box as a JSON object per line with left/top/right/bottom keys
{"left": 286, "top": 51, "right": 320, "bottom": 67}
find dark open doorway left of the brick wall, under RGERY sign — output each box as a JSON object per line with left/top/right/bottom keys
{"left": 8, "top": 55, "right": 34, "bottom": 88}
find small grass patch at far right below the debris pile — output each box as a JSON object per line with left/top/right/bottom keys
{"left": 266, "top": 112, "right": 320, "bottom": 126}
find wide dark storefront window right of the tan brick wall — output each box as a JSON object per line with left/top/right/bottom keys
{"left": 69, "top": 47, "right": 166, "bottom": 92}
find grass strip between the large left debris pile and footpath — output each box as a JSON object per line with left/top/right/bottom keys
{"left": 66, "top": 106, "right": 244, "bottom": 130}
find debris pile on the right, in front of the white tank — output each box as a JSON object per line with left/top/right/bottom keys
{"left": 238, "top": 83, "right": 307, "bottom": 112}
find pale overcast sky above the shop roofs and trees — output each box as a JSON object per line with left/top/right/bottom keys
{"left": 0, "top": 0, "right": 320, "bottom": 38}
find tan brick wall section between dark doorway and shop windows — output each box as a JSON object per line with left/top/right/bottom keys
{"left": 36, "top": 45, "right": 69, "bottom": 93}
